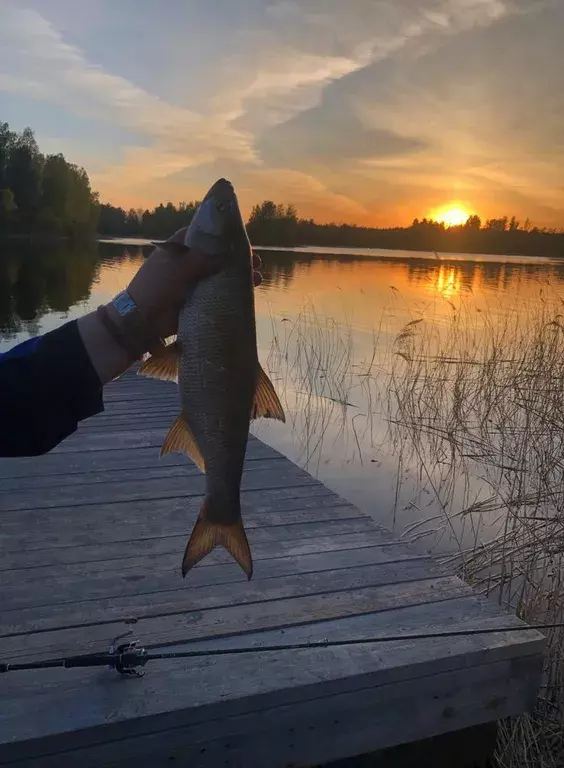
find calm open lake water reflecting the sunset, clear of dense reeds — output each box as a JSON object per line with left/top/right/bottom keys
{"left": 0, "top": 240, "right": 564, "bottom": 546}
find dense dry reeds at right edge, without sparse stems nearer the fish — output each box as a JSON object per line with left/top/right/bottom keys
{"left": 388, "top": 292, "right": 564, "bottom": 768}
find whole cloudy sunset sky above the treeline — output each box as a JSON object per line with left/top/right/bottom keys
{"left": 0, "top": 0, "right": 564, "bottom": 226}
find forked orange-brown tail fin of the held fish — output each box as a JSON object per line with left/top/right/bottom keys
{"left": 182, "top": 497, "right": 253, "bottom": 579}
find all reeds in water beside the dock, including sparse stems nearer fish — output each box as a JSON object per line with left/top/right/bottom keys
{"left": 268, "top": 289, "right": 564, "bottom": 768}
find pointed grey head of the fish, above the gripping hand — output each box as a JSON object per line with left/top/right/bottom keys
{"left": 159, "top": 178, "right": 250, "bottom": 255}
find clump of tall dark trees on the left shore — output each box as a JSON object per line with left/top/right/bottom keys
{"left": 0, "top": 122, "right": 99, "bottom": 237}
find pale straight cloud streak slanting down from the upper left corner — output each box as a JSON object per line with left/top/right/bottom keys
{"left": 0, "top": 0, "right": 251, "bottom": 164}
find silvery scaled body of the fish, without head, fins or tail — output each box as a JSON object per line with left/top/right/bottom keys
{"left": 178, "top": 259, "right": 258, "bottom": 506}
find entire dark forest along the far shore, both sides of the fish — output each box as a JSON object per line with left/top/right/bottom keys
{"left": 0, "top": 122, "right": 564, "bottom": 257}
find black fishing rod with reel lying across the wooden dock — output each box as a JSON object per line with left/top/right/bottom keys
{"left": 0, "top": 622, "right": 564, "bottom": 677}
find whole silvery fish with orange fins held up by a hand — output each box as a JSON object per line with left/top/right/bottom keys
{"left": 139, "top": 178, "right": 285, "bottom": 579}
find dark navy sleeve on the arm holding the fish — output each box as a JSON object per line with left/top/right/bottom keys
{"left": 0, "top": 321, "right": 104, "bottom": 456}
